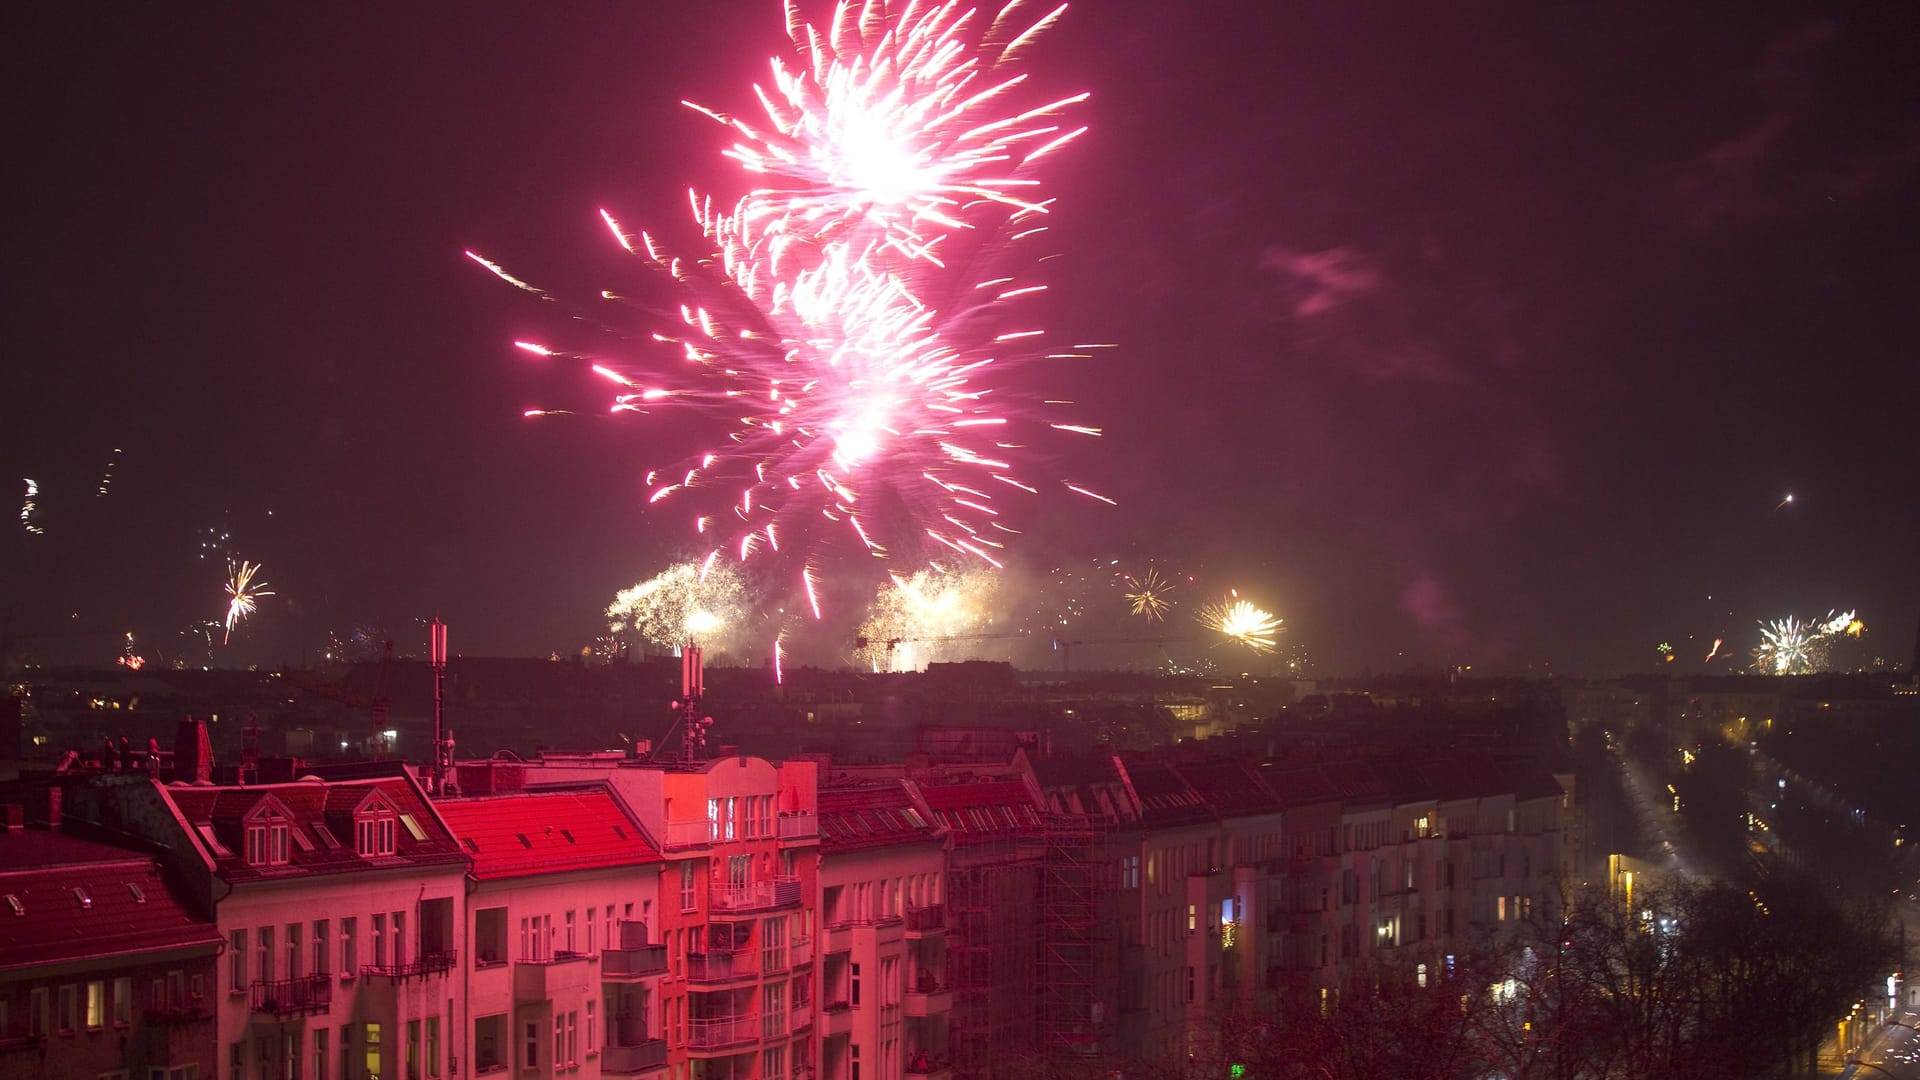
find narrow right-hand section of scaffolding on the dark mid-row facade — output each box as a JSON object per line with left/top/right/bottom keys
{"left": 1037, "top": 813, "right": 1117, "bottom": 1074}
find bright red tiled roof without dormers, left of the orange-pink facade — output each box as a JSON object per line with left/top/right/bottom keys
{"left": 434, "top": 784, "right": 660, "bottom": 882}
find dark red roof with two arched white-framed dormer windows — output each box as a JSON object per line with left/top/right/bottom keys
{"left": 159, "top": 774, "right": 467, "bottom": 884}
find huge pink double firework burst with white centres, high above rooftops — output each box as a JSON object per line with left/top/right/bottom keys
{"left": 468, "top": 0, "right": 1112, "bottom": 600}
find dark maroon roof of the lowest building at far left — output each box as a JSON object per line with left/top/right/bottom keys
{"left": 0, "top": 828, "right": 221, "bottom": 970}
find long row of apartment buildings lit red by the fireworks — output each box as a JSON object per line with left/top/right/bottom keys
{"left": 0, "top": 724, "right": 1574, "bottom": 1080}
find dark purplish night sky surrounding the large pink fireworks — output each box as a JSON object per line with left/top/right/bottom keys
{"left": 0, "top": 0, "right": 1920, "bottom": 673}
